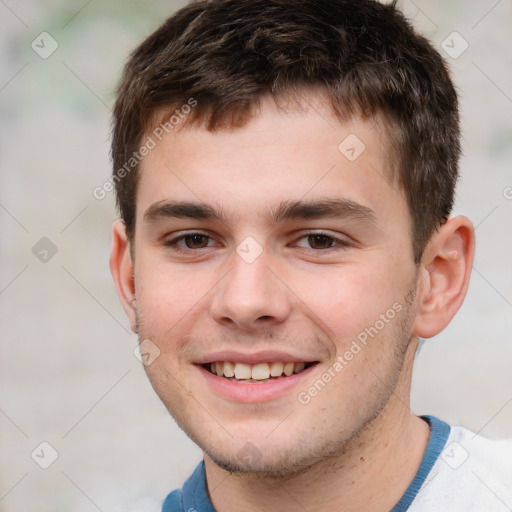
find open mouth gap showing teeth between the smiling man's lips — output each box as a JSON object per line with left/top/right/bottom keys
{"left": 202, "top": 361, "right": 317, "bottom": 383}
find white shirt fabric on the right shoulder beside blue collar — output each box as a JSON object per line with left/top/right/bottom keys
{"left": 410, "top": 427, "right": 512, "bottom": 512}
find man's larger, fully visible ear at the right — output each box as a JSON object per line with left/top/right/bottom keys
{"left": 414, "top": 216, "right": 475, "bottom": 338}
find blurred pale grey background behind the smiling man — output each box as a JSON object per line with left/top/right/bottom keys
{"left": 0, "top": 0, "right": 512, "bottom": 512}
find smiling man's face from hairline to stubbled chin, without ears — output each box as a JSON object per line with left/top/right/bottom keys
{"left": 123, "top": 98, "right": 416, "bottom": 474}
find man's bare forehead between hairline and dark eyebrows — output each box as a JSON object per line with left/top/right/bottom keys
{"left": 137, "top": 95, "right": 405, "bottom": 228}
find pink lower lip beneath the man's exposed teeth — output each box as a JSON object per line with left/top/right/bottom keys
{"left": 198, "top": 364, "right": 317, "bottom": 403}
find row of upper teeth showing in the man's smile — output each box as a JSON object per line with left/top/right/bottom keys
{"left": 210, "top": 361, "right": 306, "bottom": 380}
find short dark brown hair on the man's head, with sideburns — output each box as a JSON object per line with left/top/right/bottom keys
{"left": 112, "top": 0, "right": 460, "bottom": 262}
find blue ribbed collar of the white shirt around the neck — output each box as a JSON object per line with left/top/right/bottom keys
{"left": 162, "top": 416, "right": 450, "bottom": 512}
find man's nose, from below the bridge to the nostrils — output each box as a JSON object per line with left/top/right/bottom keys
{"left": 211, "top": 247, "right": 291, "bottom": 331}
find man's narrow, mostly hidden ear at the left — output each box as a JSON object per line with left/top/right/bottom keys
{"left": 110, "top": 220, "right": 137, "bottom": 332}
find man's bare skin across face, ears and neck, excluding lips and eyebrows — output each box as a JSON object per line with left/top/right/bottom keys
{"left": 111, "top": 92, "right": 474, "bottom": 512}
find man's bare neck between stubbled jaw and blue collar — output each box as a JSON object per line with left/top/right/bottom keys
{"left": 205, "top": 344, "right": 429, "bottom": 512}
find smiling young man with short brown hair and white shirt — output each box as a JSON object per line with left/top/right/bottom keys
{"left": 111, "top": 0, "right": 512, "bottom": 512}
